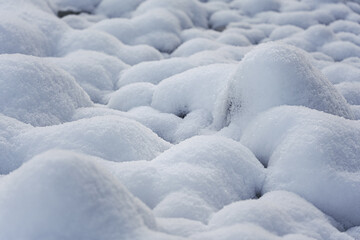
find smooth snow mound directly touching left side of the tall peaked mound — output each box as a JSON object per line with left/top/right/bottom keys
{"left": 151, "top": 64, "right": 236, "bottom": 117}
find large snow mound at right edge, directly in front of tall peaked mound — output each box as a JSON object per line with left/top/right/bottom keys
{"left": 241, "top": 106, "right": 360, "bottom": 227}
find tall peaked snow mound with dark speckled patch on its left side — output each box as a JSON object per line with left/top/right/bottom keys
{"left": 219, "top": 43, "right": 353, "bottom": 130}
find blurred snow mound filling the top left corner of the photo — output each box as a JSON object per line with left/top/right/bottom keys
{"left": 0, "top": 6, "right": 68, "bottom": 57}
